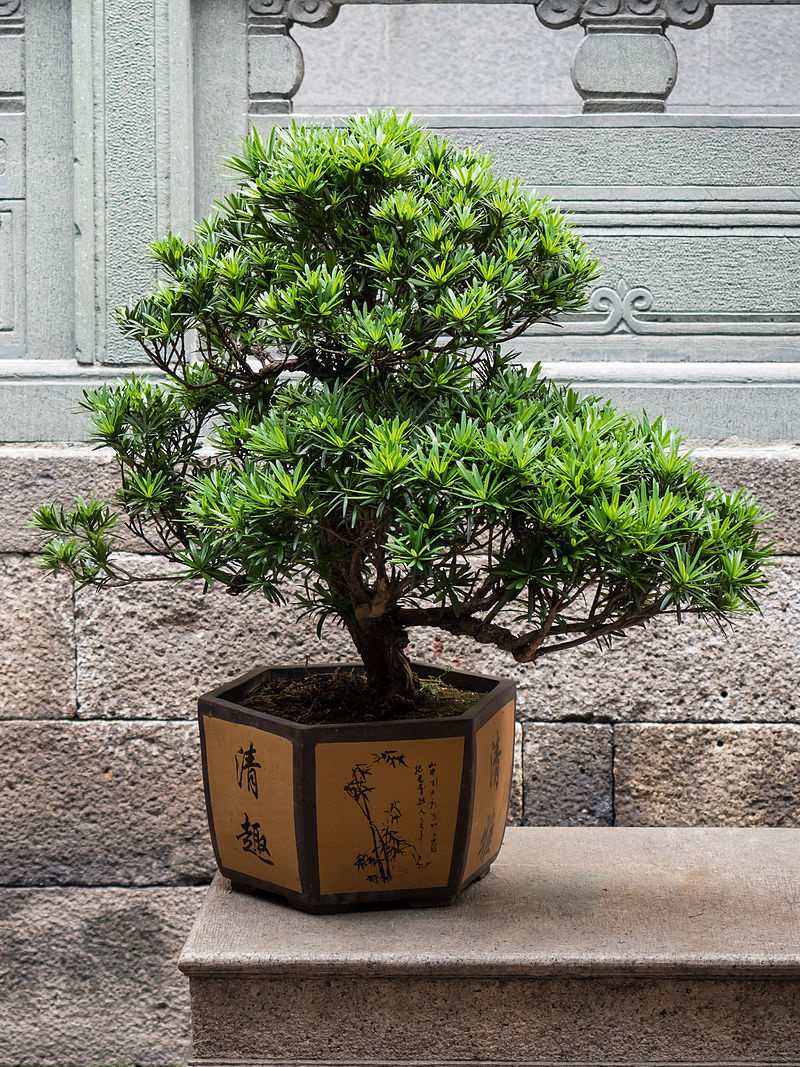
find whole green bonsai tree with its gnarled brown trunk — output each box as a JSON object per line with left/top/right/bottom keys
{"left": 34, "top": 113, "right": 768, "bottom": 715}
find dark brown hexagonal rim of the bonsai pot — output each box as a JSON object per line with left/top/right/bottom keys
{"left": 198, "top": 663, "right": 516, "bottom": 736}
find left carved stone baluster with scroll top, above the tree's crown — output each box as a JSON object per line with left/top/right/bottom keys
{"left": 247, "top": 0, "right": 339, "bottom": 114}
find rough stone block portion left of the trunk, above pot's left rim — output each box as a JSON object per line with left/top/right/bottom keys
{"left": 76, "top": 557, "right": 356, "bottom": 718}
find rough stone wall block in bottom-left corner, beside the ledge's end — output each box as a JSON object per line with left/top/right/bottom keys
{"left": 0, "top": 887, "right": 205, "bottom": 1067}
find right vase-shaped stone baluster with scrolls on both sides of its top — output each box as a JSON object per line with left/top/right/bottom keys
{"left": 534, "top": 0, "right": 714, "bottom": 112}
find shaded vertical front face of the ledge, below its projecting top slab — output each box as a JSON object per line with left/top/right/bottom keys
{"left": 188, "top": 975, "right": 800, "bottom": 1067}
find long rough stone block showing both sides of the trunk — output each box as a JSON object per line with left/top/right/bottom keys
{"left": 76, "top": 557, "right": 800, "bottom": 722}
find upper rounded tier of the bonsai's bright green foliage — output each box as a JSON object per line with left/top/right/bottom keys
{"left": 111, "top": 113, "right": 595, "bottom": 387}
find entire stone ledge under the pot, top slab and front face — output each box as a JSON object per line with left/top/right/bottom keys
{"left": 179, "top": 827, "right": 800, "bottom": 1067}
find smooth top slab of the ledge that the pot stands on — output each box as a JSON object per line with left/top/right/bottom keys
{"left": 178, "top": 827, "right": 800, "bottom": 980}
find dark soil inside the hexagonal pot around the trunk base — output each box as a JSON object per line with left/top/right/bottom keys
{"left": 239, "top": 670, "right": 481, "bottom": 724}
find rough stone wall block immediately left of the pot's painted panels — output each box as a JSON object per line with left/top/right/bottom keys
{"left": 0, "top": 721, "right": 215, "bottom": 886}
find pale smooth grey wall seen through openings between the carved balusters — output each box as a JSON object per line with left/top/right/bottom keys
{"left": 292, "top": 3, "right": 800, "bottom": 114}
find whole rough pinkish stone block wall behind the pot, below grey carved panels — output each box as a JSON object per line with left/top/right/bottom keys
{"left": 0, "top": 445, "right": 800, "bottom": 1065}
